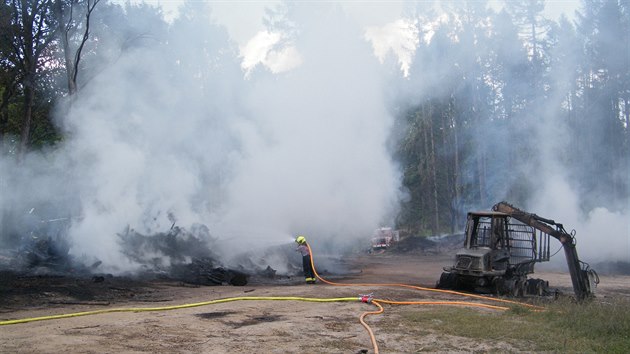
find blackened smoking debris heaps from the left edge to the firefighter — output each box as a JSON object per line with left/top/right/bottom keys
{"left": 0, "top": 212, "right": 297, "bottom": 286}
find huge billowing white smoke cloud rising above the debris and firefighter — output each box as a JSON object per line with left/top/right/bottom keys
{"left": 0, "top": 3, "right": 398, "bottom": 272}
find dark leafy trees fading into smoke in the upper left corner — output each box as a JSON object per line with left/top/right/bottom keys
{"left": 0, "top": 0, "right": 167, "bottom": 151}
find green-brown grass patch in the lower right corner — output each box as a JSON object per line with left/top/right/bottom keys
{"left": 401, "top": 299, "right": 630, "bottom": 354}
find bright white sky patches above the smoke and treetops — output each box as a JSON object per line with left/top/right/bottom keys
{"left": 144, "top": 0, "right": 580, "bottom": 74}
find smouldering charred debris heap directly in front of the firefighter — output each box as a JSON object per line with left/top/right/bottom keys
{"left": 118, "top": 224, "right": 312, "bottom": 286}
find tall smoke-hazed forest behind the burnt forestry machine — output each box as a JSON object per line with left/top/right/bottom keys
{"left": 396, "top": 1, "right": 630, "bottom": 234}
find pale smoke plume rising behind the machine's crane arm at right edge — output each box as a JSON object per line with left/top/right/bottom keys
{"left": 527, "top": 12, "right": 630, "bottom": 266}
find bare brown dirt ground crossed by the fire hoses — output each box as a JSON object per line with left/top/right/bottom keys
{"left": 0, "top": 254, "right": 630, "bottom": 353}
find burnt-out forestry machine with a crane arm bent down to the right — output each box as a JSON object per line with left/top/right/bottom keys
{"left": 437, "top": 202, "right": 599, "bottom": 300}
